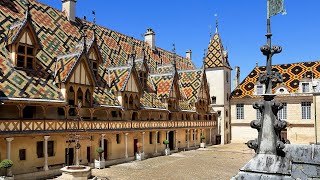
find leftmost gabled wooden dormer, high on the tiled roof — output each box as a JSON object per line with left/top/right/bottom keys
{"left": 6, "top": 9, "right": 40, "bottom": 70}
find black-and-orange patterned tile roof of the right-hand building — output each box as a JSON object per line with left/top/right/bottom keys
{"left": 230, "top": 61, "right": 320, "bottom": 99}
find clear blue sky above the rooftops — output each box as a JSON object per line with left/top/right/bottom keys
{"left": 38, "top": 0, "right": 320, "bottom": 84}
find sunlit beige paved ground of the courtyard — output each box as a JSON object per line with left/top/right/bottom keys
{"left": 92, "top": 144, "right": 254, "bottom": 180}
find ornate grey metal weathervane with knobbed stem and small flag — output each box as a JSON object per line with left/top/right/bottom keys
{"left": 247, "top": 0, "right": 287, "bottom": 155}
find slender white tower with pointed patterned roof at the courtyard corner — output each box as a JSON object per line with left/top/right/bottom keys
{"left": 203, "top": 15, "right": 232, "bottom": 144}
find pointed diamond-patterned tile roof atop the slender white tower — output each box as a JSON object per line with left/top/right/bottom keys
{"left": 205, "top": 32, "right": 231, "bottom": 69}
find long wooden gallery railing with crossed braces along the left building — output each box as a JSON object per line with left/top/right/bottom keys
{"left": 0, "top": 119, "right": 217, "bottom": 134}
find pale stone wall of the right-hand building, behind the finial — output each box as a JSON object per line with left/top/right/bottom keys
{"left": 231, "top": 95, "right": 320, "bottom": 144}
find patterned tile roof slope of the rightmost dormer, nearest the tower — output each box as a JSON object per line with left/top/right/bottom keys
{"left": 179, "top": 69, "right": 203, "bottom": 103}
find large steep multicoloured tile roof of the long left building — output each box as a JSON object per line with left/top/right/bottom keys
{"left": 0, "top": 0, "right": 215, "bottom": 110}
